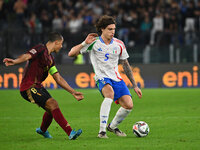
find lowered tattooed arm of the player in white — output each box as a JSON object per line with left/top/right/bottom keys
{"left": 120, "top": 59, "right": 142, "bottom": 98}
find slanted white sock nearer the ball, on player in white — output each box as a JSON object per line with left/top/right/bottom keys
{"left": 110, "top": 107, "right": 132, "bottom": 129}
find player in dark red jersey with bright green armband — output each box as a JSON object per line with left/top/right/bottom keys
{"left": 3, "top": 32, "right": 84, "bottom": 140}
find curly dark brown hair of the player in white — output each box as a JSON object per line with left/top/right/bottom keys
{"left": 95, "top": 15, "right": 116, "bottom": 34}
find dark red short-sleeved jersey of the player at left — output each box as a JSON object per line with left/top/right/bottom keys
{"left": 20, "top": 44, "right": 54, "bottom": 91}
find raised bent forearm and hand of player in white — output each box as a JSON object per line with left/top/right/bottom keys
{"left": 68, "top": 33, "right": 98, "bottom": 57}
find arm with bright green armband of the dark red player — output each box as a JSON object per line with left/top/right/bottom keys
{"left": 49, "top": 66, "right": 84, "bottom": 101}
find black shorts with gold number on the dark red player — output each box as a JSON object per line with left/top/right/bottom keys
{"left": 20, "top": 87, "right": 51, "bottom": 108}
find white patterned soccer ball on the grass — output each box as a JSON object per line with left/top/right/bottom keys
{"left": 133, "top": 121, "right": 149, "bottom": 137}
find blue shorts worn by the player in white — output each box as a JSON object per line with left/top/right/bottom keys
{"left": 97, "top": 78, "right": 132, "bottom": 104}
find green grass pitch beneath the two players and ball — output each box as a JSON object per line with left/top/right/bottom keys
{"left": 0, "top": 89, "right": 200, "bottom": 150}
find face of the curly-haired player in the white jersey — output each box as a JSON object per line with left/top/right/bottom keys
{"left": 102, "top": 24, "right": 116, "bottom": 40}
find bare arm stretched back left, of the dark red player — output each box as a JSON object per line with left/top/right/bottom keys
{"left": 3, "top": 53, "right": 32, "bottom": 66}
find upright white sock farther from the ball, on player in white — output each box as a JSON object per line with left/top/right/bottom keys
{"left": 99, "top": 98, "right": 113, "bottom": 133}
